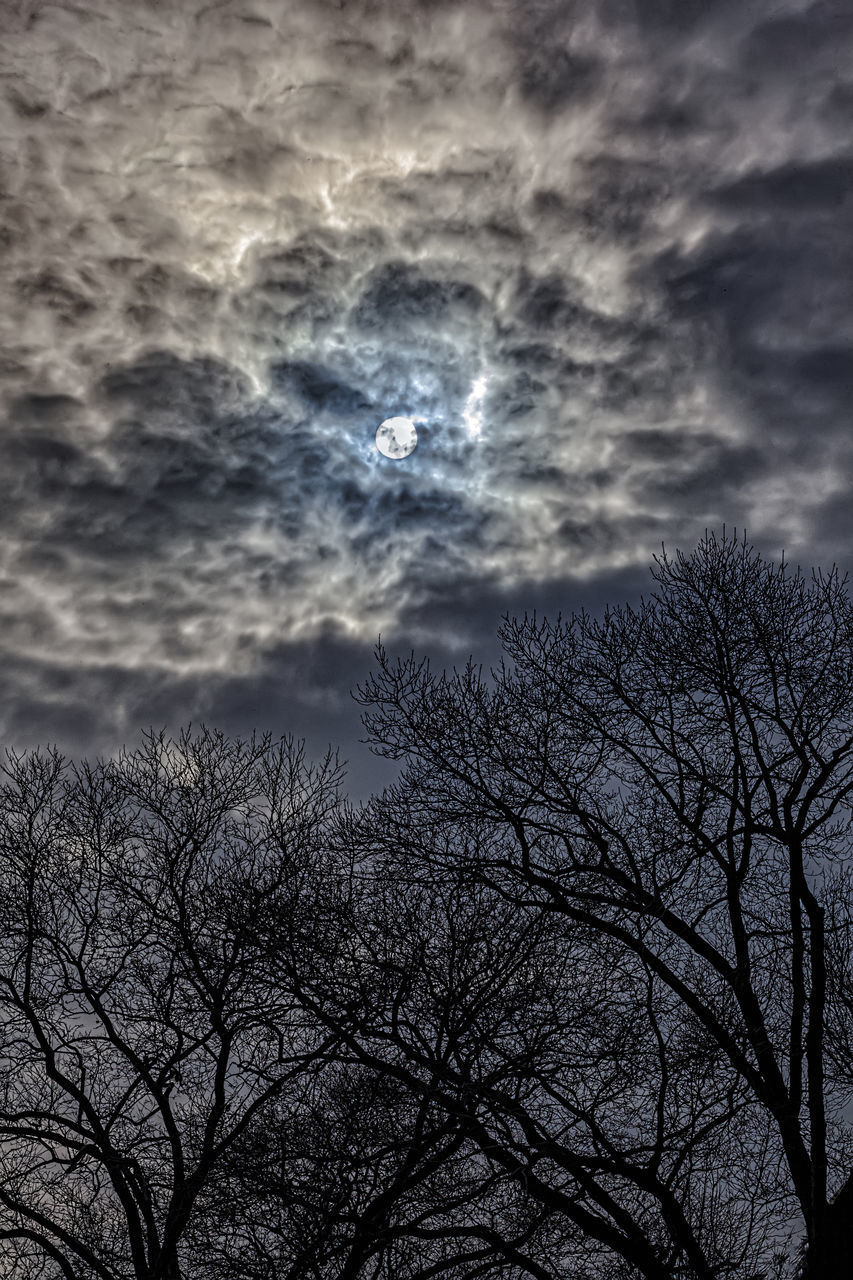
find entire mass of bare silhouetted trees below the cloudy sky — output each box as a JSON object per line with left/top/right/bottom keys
{"left": 0, "top": 535, "right": 853, "bottom": 1280}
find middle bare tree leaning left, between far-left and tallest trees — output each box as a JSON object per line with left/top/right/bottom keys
{"left": 288, "top": 790, "right": 777, "bottom": 1280}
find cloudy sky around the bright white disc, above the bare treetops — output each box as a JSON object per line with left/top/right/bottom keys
{"left": 0, "top": 0, "right": 853, "bottom": 794}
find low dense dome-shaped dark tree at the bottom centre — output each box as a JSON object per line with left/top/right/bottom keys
{"left": 199, "top": 1064, "right": 548, "bottom": 1280}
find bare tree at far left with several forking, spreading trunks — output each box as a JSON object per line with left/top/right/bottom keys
{"left": 0, "top": 731, "right": 339, "bottom": 1280}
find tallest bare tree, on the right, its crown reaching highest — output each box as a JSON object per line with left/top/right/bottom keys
{"left": 360, "top": 535, "right": 853, "bottom": 1280}
